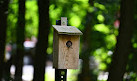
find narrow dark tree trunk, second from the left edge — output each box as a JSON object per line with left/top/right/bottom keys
{"left": 15, "top": 0, "right": 25, "bottom": 81}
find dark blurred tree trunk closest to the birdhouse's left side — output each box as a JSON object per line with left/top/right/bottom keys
{"left": 33, "top": 0, "right": 50, "bottom": 81}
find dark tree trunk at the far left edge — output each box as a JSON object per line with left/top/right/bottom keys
{"left": 0, "top": 0, "right": 9, "bottom": 81}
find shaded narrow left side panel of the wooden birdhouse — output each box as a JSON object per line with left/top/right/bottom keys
{"left": 53, "top": 30, "right": 59, "bottom": 68}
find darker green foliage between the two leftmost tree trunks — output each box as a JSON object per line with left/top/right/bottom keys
{"left": 7, "top": 0, "right": 18, "bottom": 42}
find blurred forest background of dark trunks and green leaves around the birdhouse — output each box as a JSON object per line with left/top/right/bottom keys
{"left": 0, "top": 0, "right": 137, "bottom": 81}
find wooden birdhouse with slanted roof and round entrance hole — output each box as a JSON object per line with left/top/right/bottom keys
{"left": 53, "top": 17, "right": 82, "bottom": 69}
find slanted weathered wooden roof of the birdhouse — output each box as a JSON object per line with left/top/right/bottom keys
{"left": 52, "top": 25, "right": 82, "bottom": 35}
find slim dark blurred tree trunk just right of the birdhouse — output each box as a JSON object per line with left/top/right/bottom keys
{"left": 78, "top": 0, "right": 93, "bottom": 81}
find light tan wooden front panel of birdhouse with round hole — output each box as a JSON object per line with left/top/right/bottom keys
{"left": 58, "top": 35, "right": 80, "bottom": 69}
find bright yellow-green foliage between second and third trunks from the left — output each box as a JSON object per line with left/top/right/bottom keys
{"left": 25, "top": 0, "right": 38, "bottom": 38}
